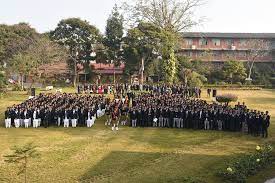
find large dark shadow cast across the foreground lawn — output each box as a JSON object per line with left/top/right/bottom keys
{"left": 79, "top": 151, "right": 228, "bottom": 183}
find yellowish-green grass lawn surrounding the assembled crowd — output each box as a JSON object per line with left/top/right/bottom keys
{"left": 0, "top": 90, "right": 275, "bottom": 183}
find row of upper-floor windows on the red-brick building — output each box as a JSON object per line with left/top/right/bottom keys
{"left": 185, "top": 38, "right": 246, "bottom": 46}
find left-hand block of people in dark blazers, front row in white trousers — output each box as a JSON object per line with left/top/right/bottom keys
{"left": 5, "top": 93, "right": 110, "bottom": 128}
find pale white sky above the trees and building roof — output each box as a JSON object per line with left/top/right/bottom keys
{"left": 0, "top": 0, "right": 275, "bottom": 33}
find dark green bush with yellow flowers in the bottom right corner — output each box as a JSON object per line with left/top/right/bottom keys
{"left": 219, "top": 145, "right": 274, "bottom": 183}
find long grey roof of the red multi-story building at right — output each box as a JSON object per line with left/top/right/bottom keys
{"left": 182, "top": 32, "right": 275, "bottom": 39}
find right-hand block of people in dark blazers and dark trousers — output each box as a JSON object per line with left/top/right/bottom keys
{"left": 129, "top": 94, "right": 270, "bottom": 137}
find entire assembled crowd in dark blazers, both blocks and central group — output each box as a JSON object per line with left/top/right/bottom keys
{"left": 5, "top": 85, "right": 270, "bottom": 137}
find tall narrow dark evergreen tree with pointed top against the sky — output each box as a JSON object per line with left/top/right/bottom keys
{"left": 103, "top": 5, "right": 123, "bottom": 65}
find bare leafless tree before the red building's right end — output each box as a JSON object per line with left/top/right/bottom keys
{"left": 246, "top": 39, "right": 270, "bottom": 81}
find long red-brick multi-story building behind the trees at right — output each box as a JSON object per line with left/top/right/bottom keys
{"left": 179, "top": 32, "right": 275, "bottom": 63}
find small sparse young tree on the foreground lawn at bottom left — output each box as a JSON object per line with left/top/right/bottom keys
{"left": 4, "top": 143, "right": 40, "bottom": 183}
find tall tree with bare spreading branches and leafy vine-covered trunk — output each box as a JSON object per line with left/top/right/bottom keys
{"left": 124, "top": 0, "right": 204, "bottom": 83}
